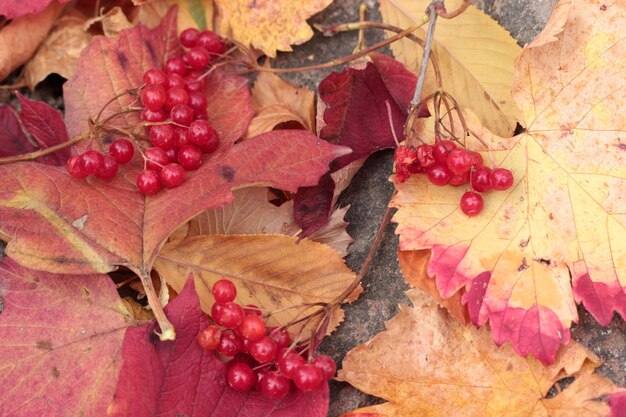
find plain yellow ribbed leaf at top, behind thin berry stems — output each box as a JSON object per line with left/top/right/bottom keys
{"left": 380, "top": 0, "right": 522, "bottom": 136}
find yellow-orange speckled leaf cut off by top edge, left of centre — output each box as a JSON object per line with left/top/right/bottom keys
{"left": 216, "top": 0, "right": 332, "bottom": 58}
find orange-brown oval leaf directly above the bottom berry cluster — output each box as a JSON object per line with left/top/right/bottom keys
{"left": 155, "top": 235, "right": 355, "bottom": 337}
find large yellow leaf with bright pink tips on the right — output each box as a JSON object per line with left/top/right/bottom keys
{"left": 392, "top": 1, "right": 626, "bottom": 363}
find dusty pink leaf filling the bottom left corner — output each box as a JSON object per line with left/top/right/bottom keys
{"left": 0, "top": 258, "right": 130, "bottom": 417}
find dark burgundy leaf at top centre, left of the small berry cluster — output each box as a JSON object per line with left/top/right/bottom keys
{"left": 294, "top": 54, "right": 417, "bottom": 236}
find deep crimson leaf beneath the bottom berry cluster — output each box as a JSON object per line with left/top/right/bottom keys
{"left": 109, "top": 279, "right": 328, "bottom": 417}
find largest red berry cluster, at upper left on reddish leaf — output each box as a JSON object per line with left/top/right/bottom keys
{"left": 67, "top": 28, "right": 226, "bottom": 195}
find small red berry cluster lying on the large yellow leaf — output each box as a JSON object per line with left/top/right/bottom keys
{"left": 394, "top": 140, "right": 513, "bottom": 216}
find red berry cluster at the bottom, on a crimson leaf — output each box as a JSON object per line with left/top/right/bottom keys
{"left": 197, "top": 279, "right": 337, "bottom": 399}
